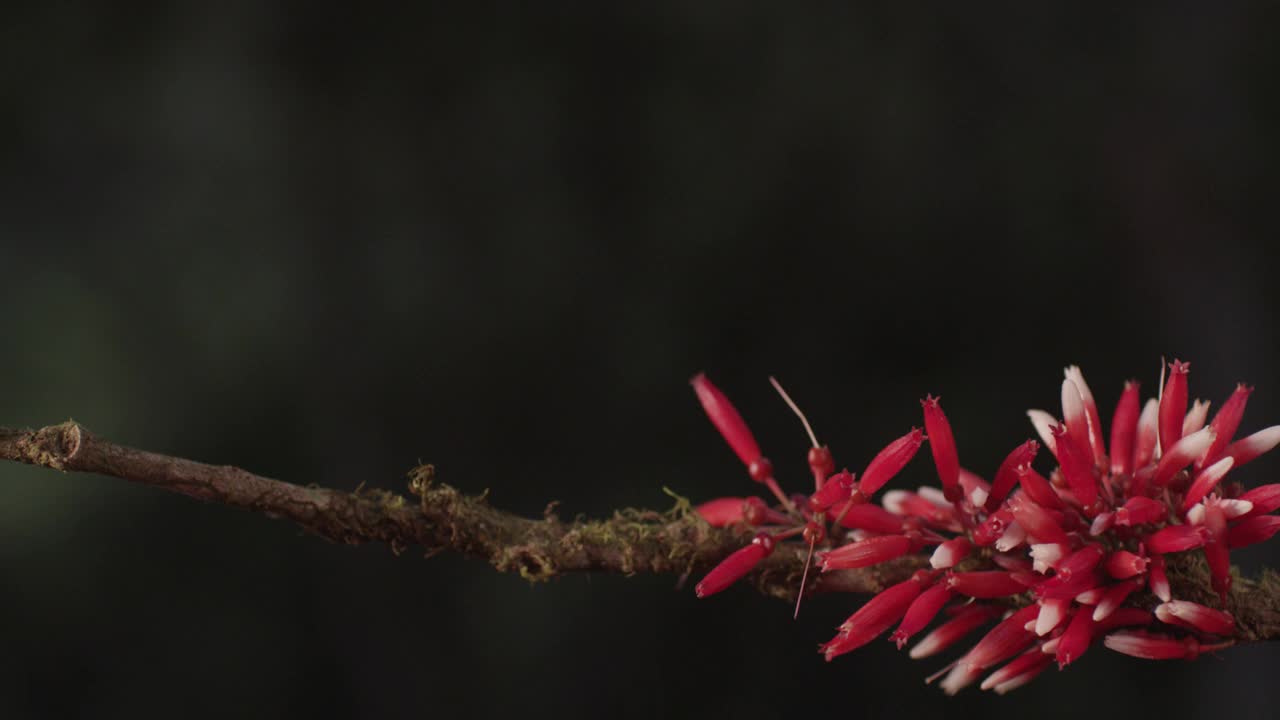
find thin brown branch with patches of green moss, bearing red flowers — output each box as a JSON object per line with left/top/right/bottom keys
{"left": 0, "top": 421, "right": 1280, "bottom": 641}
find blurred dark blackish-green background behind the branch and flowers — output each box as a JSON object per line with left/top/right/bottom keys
{"left": 0, "top": 1, "right": 1280, "bottom": 719}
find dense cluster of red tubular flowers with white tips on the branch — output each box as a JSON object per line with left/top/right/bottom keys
{"left": 692, "top": 360, "right": 1280, "bottom": 693}
